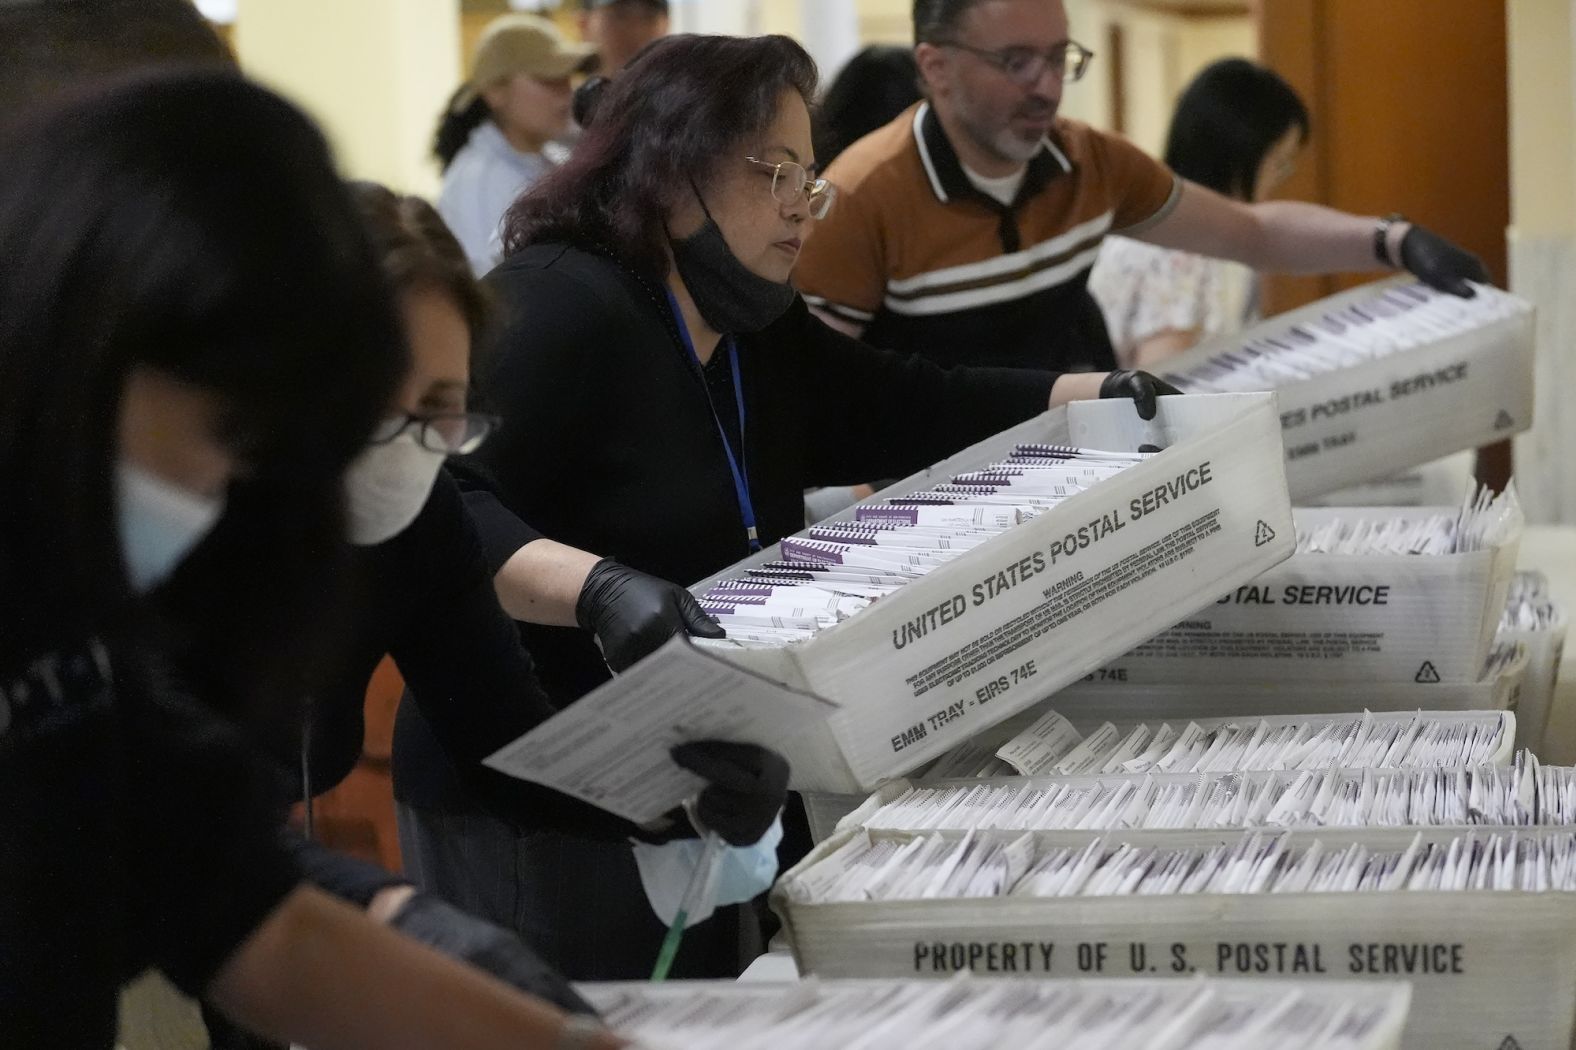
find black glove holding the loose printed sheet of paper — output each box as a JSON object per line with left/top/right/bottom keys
{"left": 668, "top": 739, "right": 788, "bottom": 845}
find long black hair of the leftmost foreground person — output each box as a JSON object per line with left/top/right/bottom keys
{"left": 0, "top": 73, "right": 408, "bottom": 703}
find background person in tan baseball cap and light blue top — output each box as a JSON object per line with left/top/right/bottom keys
{"left": 433, "top": 14, "right": 596, "bottom": 276}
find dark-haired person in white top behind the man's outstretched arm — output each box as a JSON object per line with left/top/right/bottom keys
{"left": 1089, "top": 58, "right": 1310, "bottom": 367}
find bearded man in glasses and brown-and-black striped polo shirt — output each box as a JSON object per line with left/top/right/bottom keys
{"left": 794, "top": 0, "right": 1488, "bottom": 370}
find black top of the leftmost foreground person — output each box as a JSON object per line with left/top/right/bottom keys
{"left": 0, "top": 633, "right": 299, "bottom": 1047}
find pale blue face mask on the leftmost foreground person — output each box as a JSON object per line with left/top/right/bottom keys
{"left": 115, "top": 460, "right": 224, "bottom": 594}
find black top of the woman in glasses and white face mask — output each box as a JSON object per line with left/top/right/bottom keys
{"left": 312, "top": 473, "right": 634, "bottom": 838}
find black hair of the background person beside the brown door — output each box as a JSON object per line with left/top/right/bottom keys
{"left": 1165, "top": 58, "right": 1310, "bottom": 200}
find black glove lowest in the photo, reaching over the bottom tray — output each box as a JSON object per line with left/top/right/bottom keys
{"left": 389, "top": 894, "right": 596, "bottom": 1017}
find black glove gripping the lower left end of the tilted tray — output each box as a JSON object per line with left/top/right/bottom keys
{"left": 575, "top": 558, "right": 725, "bottom": 672}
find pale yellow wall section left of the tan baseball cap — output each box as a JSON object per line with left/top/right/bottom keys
{"left": 233, "top": 0, "right": 460, "bottom": 194}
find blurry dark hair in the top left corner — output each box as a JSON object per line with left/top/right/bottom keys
{"left": 0, "top": 0, "right": 235, "bottom": 121}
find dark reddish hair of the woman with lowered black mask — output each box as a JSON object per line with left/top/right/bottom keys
{"left": 504, "top": 35, "right": 816, "bottom": 276}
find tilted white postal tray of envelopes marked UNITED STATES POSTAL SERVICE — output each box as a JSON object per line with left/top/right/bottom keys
{"left": 692, "top": 394, "right": 1294, "bottom": 791}
